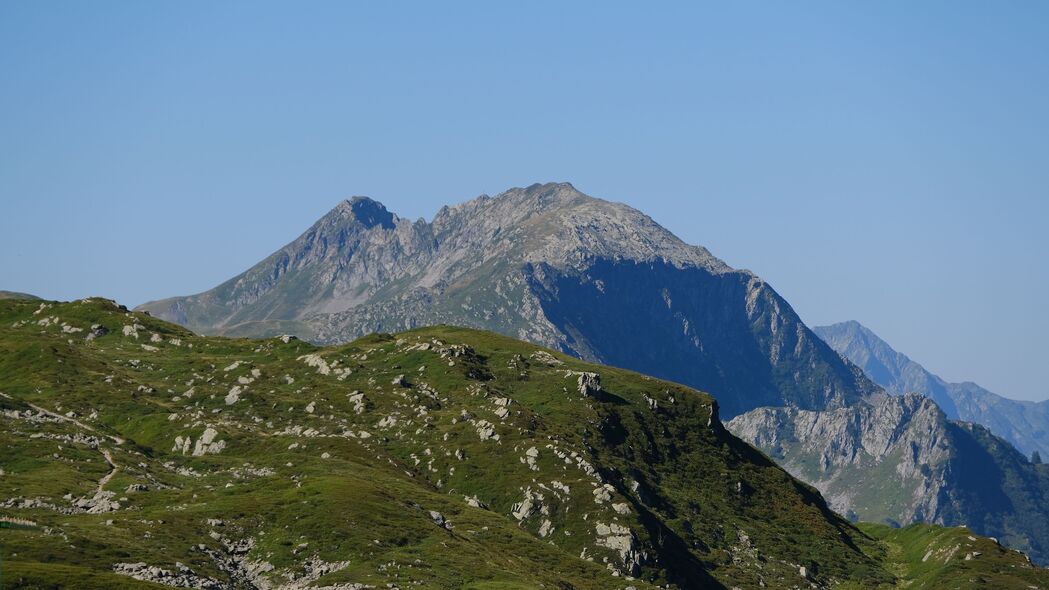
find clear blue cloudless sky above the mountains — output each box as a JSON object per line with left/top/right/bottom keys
{"left": 0, "top": 0, "right": 1049, "bottom": 400}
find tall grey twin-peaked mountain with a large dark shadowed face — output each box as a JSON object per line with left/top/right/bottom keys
{"left": 140, "top": 184, "right": 878, "bottom": 416}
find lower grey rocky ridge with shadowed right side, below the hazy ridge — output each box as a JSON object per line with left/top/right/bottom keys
{"left": 726, "top": 394, "right": 1049, "bottom": 563}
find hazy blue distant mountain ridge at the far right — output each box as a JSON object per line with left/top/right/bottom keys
{"left": 813, "top": 321, "right": 1049, "bottom": 457}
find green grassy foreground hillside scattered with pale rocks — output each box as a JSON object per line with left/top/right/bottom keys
{"left": 6, "top": 299, "right": 1049, "bottom": 590}
